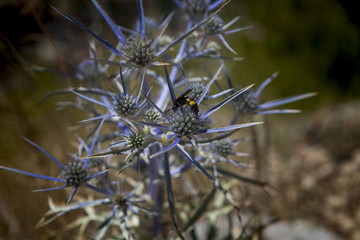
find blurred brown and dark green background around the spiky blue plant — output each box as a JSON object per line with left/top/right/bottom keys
{"left": 0, "top": 0, "right": 360, "bottom": 240}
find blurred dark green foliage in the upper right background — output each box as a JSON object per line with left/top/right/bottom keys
{"left": 227, "top": 0, "right": 360, "bottom": 106}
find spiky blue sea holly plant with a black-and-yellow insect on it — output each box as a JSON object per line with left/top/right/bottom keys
{"left": 0, "top": 0, "right": 314, "bottom": 239}
